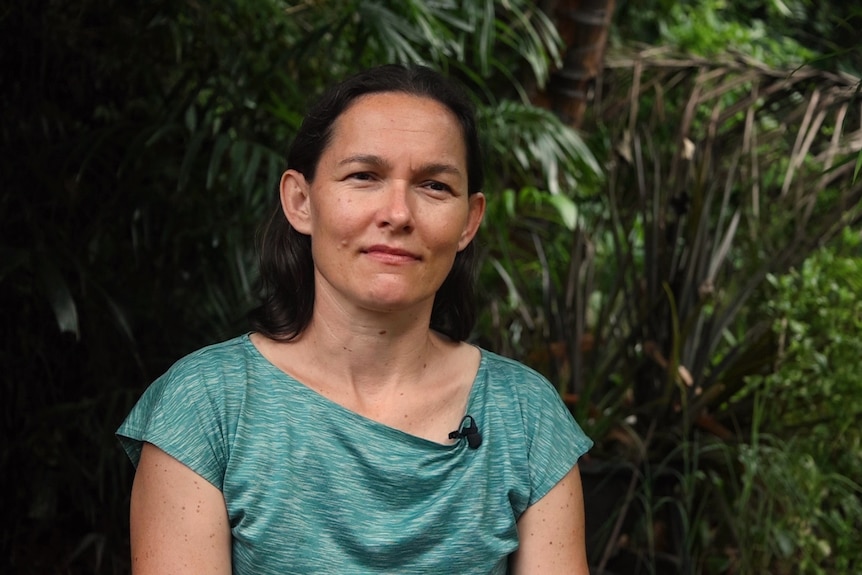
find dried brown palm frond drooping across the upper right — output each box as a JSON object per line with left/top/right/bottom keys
{"left": 595, "top": 48, "right": 862, "bottom": 251}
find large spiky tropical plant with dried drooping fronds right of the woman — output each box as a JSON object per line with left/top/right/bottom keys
{"left": 480, "top": 44, "right": 862, "bottom": 573}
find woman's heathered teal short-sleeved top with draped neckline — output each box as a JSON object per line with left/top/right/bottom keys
{"left": 117, "top": 335, "right": 592, "bottom": 575}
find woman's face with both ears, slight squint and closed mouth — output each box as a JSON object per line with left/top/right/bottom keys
{"left": 281, "top": 92, "right": 485, "bottom": 320}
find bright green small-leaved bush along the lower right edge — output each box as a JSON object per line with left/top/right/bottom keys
{"left": 737, "top": 229, "right": 862, "bottom": 575}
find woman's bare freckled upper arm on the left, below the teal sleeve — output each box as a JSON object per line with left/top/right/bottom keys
{"left": 130, "top": 443, "right": 231, "bottom": 575}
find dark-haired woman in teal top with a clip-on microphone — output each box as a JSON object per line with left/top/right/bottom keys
{"left": 118, "top": 66, "right": 591, "bottom": 575}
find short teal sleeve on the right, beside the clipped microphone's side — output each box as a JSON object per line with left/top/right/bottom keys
{"left": 524, "top": 374, "right": 593, "bottom": 505}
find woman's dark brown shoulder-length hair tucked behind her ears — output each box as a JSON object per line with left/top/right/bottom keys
{"left": 249, "top": 64, "right": 484, "bottom": 341}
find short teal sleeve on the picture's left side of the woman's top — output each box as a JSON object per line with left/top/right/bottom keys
{"left": 117, "top": 356, "right": 229, "bottom": 489}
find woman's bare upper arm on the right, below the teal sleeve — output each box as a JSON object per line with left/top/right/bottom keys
{"left": 510, "top": 466, "right": 589, "bottom": 575}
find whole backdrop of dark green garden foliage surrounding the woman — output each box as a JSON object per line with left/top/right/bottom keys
{"left": 0, "top": 0, "right": 862, "bottom": 575}
